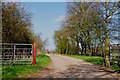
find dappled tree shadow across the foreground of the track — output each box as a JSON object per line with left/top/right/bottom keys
{"left": 48, "top": 65, "right": 116, "bottom": 78}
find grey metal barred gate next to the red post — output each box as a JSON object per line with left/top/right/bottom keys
{"left": 0, "top": 43, "right": 33, "bottom": 64}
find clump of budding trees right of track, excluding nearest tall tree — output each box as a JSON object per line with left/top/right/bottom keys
{"left": 54, "top": 2, "right": 104, "bottom": 55}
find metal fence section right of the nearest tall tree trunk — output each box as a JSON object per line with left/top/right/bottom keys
{"left": 110, "top": 44, "right": 120, "bottom": 66}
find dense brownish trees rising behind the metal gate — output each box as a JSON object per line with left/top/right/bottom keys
{"left": 2, "top": 2, "right": 44, "bottom": 50}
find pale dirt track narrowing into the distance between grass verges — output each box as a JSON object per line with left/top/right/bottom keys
{"left": 30, "top": 54, "right": 118, "bottom": 78}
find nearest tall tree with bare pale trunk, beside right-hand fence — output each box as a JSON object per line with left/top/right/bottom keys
{"left": 98, "top": 2, "right": 120, "bottom": 67}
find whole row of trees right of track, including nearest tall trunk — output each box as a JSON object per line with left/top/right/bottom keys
{"left": 55, "top": 2, "right": 120, "bottom": 67}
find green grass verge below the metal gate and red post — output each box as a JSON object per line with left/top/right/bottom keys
{"left": 2, "top": 54, "right": 51, "bottom": 78}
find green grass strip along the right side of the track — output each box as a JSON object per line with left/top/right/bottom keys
{"left": 63, "top": 54, "right": 120, "bottom": 73}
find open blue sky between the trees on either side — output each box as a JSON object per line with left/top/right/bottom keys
{"left": 23, "top": 2, "right": 66, "bottom": 50}
